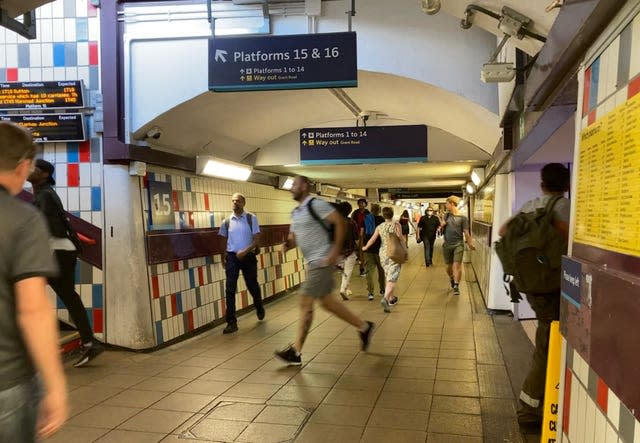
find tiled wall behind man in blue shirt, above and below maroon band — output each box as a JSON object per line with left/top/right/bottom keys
{"left": 141, "top": 169, "right": 304, "bottom": 344}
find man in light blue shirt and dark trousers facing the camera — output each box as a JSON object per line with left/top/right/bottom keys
{"left": 218, "top": 193, "right": 264, "bottom": 334}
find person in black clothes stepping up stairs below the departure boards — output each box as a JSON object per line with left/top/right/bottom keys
{"left": 28, "top": 159, "right": 104, "bottom": 368}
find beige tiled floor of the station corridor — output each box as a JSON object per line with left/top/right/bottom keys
{"left": 51, "top": 245, "right": 523, "bottom": 443}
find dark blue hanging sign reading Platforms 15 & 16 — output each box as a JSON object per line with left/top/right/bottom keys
{"left": 209, "top": 32, "right": 358, "bottom": 92}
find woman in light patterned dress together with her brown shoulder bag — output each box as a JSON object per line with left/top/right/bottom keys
{"left": 362, "top": 207, "right": 409, "bottom": 312}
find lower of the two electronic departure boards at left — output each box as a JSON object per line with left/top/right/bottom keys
{"left": 0, "top": 114, "right": 86, "bottom": 143}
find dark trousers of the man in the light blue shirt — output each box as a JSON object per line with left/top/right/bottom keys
{"left": 224, "top": 252, "right": 262, "bottom": 323}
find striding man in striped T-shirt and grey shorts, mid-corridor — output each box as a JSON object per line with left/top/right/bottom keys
{"left": 276, "top": 176, "right": 373, "bottom": 365}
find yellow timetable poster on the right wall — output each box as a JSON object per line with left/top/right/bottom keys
{"left": 574, "top": 94, "right": 640, "bottom": 256}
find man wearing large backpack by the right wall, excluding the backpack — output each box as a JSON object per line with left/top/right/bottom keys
{"left": 499, "top": 163, "right": 571, "bottom": 430}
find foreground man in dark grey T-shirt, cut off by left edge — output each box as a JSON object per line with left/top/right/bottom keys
{"left": 0, "top": 122, "right": 68, "bottom": 442}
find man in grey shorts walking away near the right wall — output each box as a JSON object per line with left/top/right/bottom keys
{"left": 440, "top": 195, "right": 476, "bottom": 295}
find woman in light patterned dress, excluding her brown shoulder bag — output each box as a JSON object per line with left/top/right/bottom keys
{"left": 362, "top": 207, "right": 407, "bottom": 312}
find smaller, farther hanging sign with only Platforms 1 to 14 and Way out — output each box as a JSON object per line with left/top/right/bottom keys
{"left": 300, "top": 125, "right": 427, "bottom": 164}
